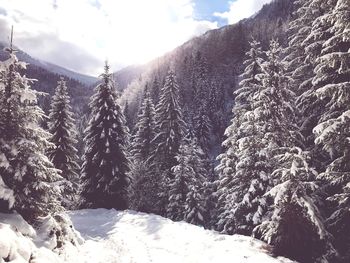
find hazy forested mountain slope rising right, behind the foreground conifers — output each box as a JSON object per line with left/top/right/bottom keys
{"left": 115, "top": 0, "right": 294, "bottom": 159}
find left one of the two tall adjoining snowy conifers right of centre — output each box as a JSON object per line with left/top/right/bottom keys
{"left": 215, "top": 41, "right": 263, "bottom": 234}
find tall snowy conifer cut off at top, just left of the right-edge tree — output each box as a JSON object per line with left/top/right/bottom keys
{"left": 296, "top": 0, "right": 334, "bottom": 171}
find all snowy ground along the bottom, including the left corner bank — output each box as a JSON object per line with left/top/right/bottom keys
{"left": 0, "top": 209, "right": 292, "bottom": 263}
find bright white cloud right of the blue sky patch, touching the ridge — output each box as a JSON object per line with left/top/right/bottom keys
{"left": 214, "top": 0, "right": 271, "bottom": 24}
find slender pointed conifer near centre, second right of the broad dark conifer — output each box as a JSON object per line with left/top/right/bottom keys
{"left": 152, "top": 70, "right": 185, "bottom": 214}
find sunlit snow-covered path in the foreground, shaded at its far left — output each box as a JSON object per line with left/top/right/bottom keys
{"left": 66, "top": 209, "right": 291, "bottom": 263}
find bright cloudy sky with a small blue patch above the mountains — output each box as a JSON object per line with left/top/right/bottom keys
{"left": 0, "top": 0, "right": 271, "bottom": 76}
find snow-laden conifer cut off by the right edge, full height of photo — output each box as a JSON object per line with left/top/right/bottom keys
{"left": 313, "top": 0, "right": 350, "bottom": 262}
